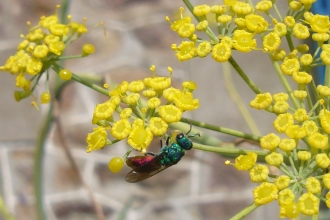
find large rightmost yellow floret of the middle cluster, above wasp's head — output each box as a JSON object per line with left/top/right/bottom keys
{"left": 174, "top": 92, "right": 199, "bottom": 111}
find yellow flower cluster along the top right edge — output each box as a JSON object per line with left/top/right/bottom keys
{"left": 166, "top": 0, "right": 330, "bottom": 66}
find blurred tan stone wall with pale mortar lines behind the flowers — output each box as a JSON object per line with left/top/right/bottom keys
{"left": 0, "top": 0, "right": 310, "bottom": 220}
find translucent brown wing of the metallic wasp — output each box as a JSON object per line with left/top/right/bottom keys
{"left": 126, "top": 154, "right": 171, "bottom": 183}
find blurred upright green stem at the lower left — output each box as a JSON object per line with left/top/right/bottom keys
{"left": 33, "top": 103, "right": 53, "bottom": 220}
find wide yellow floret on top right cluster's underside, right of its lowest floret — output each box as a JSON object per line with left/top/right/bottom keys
{"left": 233, "top": 30, "right": 257, "bottom": 52}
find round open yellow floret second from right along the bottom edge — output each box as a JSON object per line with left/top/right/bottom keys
{"left": 298, "top": 192, "right": 320, "bottom": 216}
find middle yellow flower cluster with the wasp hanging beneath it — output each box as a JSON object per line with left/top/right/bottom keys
{"left": 86, "top": 66, "right": 199, "bottom": 152}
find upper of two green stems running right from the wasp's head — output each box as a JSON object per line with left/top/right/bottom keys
{"left": 180, "top": 118, "right": 260, "bottom": 142}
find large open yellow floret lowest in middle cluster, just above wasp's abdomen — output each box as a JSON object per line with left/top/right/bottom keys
{"left": 127, "top": 119, "right": 153, "bottom": 151}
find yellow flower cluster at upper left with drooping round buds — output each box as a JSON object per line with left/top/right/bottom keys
{"left": 0, "top": 6, "right": 95, "bottom": 107}
